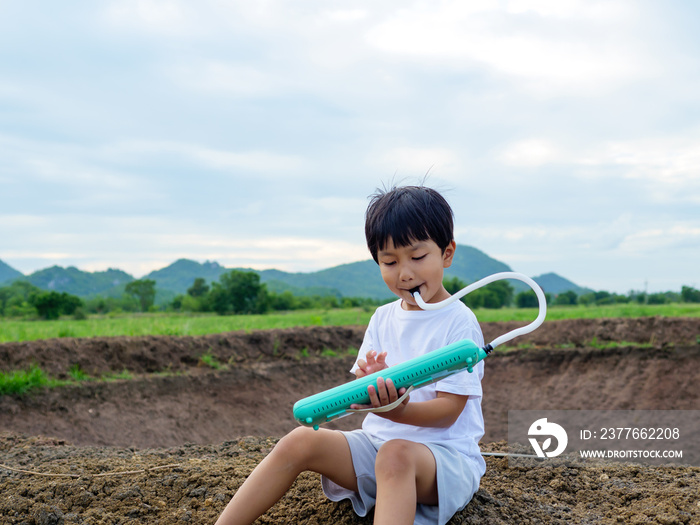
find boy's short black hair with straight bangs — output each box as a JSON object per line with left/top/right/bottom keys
{"left": 365, "top": 186, "right": 454, "bottom": 262}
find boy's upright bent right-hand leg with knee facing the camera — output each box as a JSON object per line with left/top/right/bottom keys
{"left": 374, "top": 439, "right": 438, "bottom": 525}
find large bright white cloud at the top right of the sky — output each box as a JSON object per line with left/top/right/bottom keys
{"left": 368, "top": 0, "right": 653, "bottom": 95}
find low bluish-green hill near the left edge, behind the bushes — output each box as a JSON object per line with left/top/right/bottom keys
{"left": 25, "top": 266, "right": 134, "bottom": 297}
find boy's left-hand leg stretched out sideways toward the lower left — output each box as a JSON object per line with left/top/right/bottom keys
{"left": 216, "top": 427, "right": 357, "bottom": 525}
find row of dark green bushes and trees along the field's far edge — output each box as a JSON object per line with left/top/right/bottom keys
{"left": 0, "top": 270, "right": 700, "bottom": 320}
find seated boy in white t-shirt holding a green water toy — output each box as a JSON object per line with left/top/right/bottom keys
{"left": 217, "top": 186, "right": 486, "bottom": 525}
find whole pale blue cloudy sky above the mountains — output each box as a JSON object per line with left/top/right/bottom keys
{"left": 0, "top": 0, "right": 700, "bottom": 293}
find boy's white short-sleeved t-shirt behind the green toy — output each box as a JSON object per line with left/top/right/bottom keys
{"left": 351, "top": 300, "right": 486, "bottom": 475}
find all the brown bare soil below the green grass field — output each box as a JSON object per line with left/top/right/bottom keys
{"left": 0, "top": 318, "right": 700, "bottom": 525}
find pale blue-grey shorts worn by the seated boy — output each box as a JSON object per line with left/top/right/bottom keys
{"left": 321, "top": 430, "right": 481, "bottom": 525}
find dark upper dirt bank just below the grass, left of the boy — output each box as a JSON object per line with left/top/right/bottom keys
{"left": 0, "top": 326, "right": 365, "bottom": 379}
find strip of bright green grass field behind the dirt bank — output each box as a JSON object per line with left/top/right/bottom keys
{"left": 0, "top": 303, "right": 700, "bottom": 343}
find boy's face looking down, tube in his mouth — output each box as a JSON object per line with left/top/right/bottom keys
{"left": 377, "top": 238, "right": 455, "bottom": 310}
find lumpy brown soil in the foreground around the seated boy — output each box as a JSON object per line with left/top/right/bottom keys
{"left": 0, "top": 434, "right": 700, "bottom": 525}
